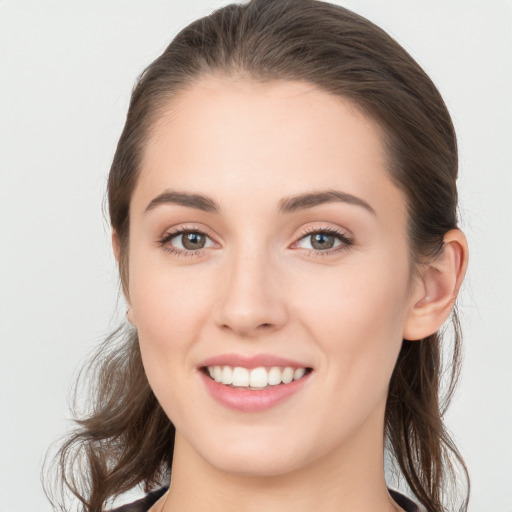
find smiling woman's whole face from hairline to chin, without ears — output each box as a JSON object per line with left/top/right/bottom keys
{"left": 128, "top": 77, "right": 418, "bottom": 475}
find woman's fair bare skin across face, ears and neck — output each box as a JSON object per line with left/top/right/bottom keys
{"left": 114, "top": 76, "right": 467, "bottom": 512}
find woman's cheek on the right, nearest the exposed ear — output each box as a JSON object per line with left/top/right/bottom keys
{"left": 294, "top": 259, "right": 409, "bottom": 393}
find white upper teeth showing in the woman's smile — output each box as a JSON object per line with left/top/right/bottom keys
{"left": 207, "top": 366, "right": 306, "bottom": 389}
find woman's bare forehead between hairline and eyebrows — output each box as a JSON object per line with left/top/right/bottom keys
{"left": 133, "top": 76, "right": 402, "bottom": 222}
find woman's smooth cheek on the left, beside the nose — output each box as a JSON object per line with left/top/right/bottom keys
{"left": 129, "top": 246, "right": 218, "bottom": 386}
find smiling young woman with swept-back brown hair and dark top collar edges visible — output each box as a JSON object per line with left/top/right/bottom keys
{"left": 50, "top": 0, "right": 468, "bottom": 512}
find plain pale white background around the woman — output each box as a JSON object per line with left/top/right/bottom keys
{"left": 0, "top": 0, "right": 512, "bottom": 512}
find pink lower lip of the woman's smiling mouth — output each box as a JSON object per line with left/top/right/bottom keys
{"left": 199, "top": 372, "right": 311, "bottom": 412}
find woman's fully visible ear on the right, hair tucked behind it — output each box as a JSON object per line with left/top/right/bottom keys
{"left": 403, "top": 229, "right": 468, "bottom": 340}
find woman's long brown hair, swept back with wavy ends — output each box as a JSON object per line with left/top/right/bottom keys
{"left": 46, "top": 0, "right": 469, "bottom": 512}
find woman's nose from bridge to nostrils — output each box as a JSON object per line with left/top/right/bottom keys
{"left": 215, "top": 246, "right": 288, "bottom": 338}
